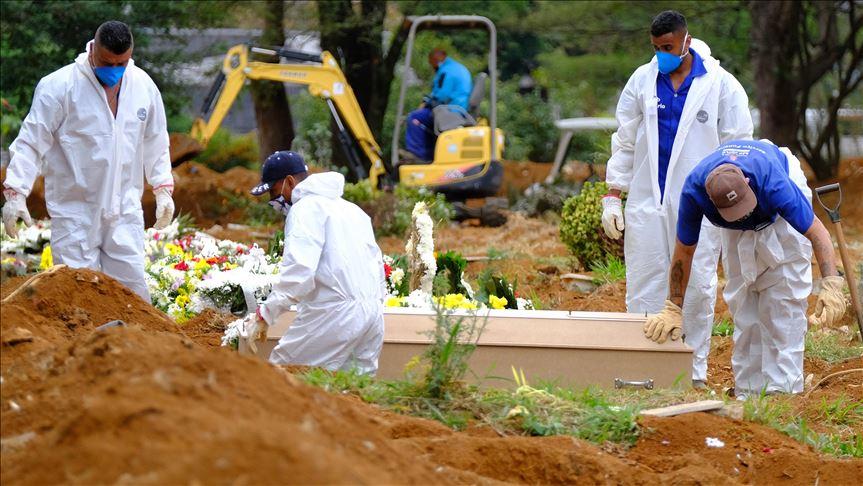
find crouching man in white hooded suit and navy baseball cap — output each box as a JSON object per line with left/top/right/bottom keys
{"left": 246, "top": 151, "right": 386, "bottom": 374}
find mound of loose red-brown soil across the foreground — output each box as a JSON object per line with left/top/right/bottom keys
{"left": 0, "top": 269, "right": 863, "bottom": 484}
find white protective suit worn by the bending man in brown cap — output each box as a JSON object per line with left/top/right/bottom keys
{"left": 724, "top": 147, "right": 812, "bottom": 398}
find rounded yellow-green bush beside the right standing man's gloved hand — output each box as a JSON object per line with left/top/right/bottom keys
{"left": 560, "top": 182, "right": 623, "bottom": 265}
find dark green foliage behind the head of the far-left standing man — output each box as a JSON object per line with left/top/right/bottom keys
{"left": 0, "top": 0, "right": 240, "bottom": 144}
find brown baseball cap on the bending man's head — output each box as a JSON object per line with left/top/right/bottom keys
{"left": 704, "top": 164, "right": 758, "bottom": 223}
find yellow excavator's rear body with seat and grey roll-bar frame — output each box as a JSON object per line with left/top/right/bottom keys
{"left": 389, "top": 15, "right": 504, "bottom": 201}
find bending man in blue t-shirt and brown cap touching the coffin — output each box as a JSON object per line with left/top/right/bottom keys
{"left": 644, "top": 140, "right": 846, "bottom": 398}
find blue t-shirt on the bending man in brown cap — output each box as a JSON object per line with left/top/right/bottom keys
{"left": 677, "top": 140, "right": 815, "bottom": 246}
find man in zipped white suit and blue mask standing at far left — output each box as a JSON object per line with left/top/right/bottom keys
{"left": 3, "top": 21, "right": 174, "bottom": 302}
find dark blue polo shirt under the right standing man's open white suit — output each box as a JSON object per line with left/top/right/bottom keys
{"left": 656, "top": 49, "right": 707, "bottom": 198}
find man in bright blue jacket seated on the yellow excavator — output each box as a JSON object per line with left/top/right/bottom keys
{"left": 405, "top": 49, "right": 473, "bottom": 161}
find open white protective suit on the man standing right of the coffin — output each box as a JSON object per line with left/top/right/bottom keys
{"left": 606, "top": 39, "right": 752, "bottom": 381}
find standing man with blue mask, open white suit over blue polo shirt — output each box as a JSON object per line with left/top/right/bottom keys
{"left": 602, "top": 11, "right": 752, "bottom": 387}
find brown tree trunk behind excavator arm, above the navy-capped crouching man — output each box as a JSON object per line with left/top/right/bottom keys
{"left": 249, "top": 0, "right": 294, "bottom": 159}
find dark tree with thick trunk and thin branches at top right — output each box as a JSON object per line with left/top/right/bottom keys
{"left": 749, "top": 0, "right": 863, "bottom": 179}
